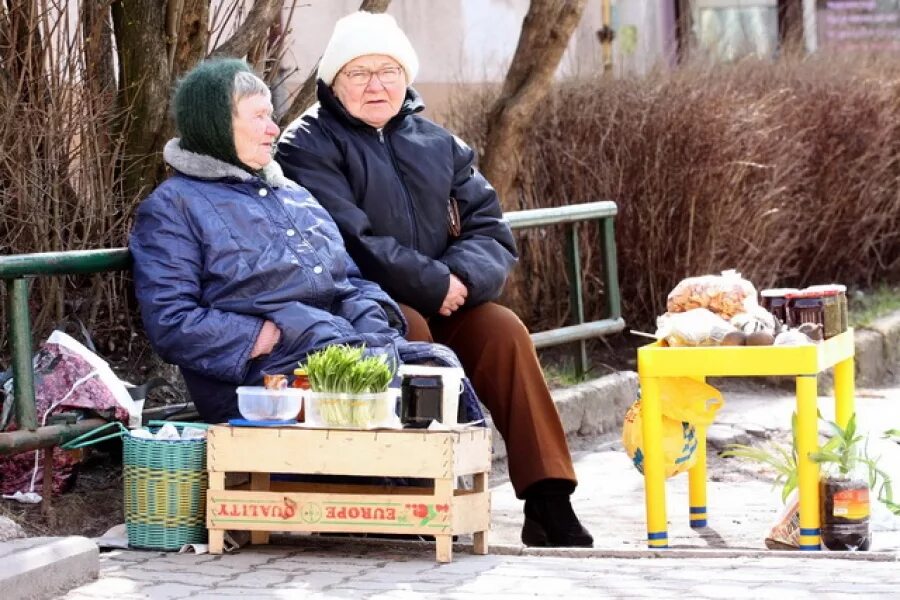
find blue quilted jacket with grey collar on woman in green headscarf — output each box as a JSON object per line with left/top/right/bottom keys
{"left": 129, "top": 140, "right": 405, "bottom": 416}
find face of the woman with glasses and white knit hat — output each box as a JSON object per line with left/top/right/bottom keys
{"left": 331, "top": 54, "right": 406, "bottom": 128}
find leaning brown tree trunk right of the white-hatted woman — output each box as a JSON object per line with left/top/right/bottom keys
{"left": 481, "top": 0, "right": 586, "bottom": 210}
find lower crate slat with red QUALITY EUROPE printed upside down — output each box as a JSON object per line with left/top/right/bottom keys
{"left": 207, "top": 490, "right": 482, "bottom": 535}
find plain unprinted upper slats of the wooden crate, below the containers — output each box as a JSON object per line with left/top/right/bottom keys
{"left": 207, "top": 427, "right": 490, "bottom": 478}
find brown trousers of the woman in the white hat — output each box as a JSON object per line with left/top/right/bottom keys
{"left": 400, "top": 302, "right": 576, "bottom": 498}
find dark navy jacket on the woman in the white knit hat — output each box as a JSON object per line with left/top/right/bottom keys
{"left": 275, "top": 81, "right": 517, "bottom": 316}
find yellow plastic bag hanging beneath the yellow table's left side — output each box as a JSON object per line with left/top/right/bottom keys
{"left": 622, "top": 377, "right": 724, "bottom": 477}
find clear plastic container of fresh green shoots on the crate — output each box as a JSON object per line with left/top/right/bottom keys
{"left": 302, "top": 345, "right": 400, "bottom": 429}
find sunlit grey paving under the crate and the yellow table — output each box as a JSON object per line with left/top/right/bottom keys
{"left": 51, "top": 388, "right": 900, "bottom": 600}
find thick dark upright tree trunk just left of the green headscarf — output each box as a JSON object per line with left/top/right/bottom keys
{"left": 112, "top": 0, "right": 171, "bottom": 203}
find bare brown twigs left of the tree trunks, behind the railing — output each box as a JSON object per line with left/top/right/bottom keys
{"left": 0, "top": 1, "right": 131, "bottom": 352}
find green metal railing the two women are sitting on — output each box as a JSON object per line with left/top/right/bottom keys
{"left": 0, "top": 202, "right": 625, "bottom": 455}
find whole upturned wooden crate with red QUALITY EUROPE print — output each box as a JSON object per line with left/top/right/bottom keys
{"left": 206, "top": 425, "right": 491, "bottom": 562}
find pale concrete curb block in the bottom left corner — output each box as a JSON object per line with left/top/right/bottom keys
{"left": 0, "top": 536, "right": 100, "bottom": 600}
